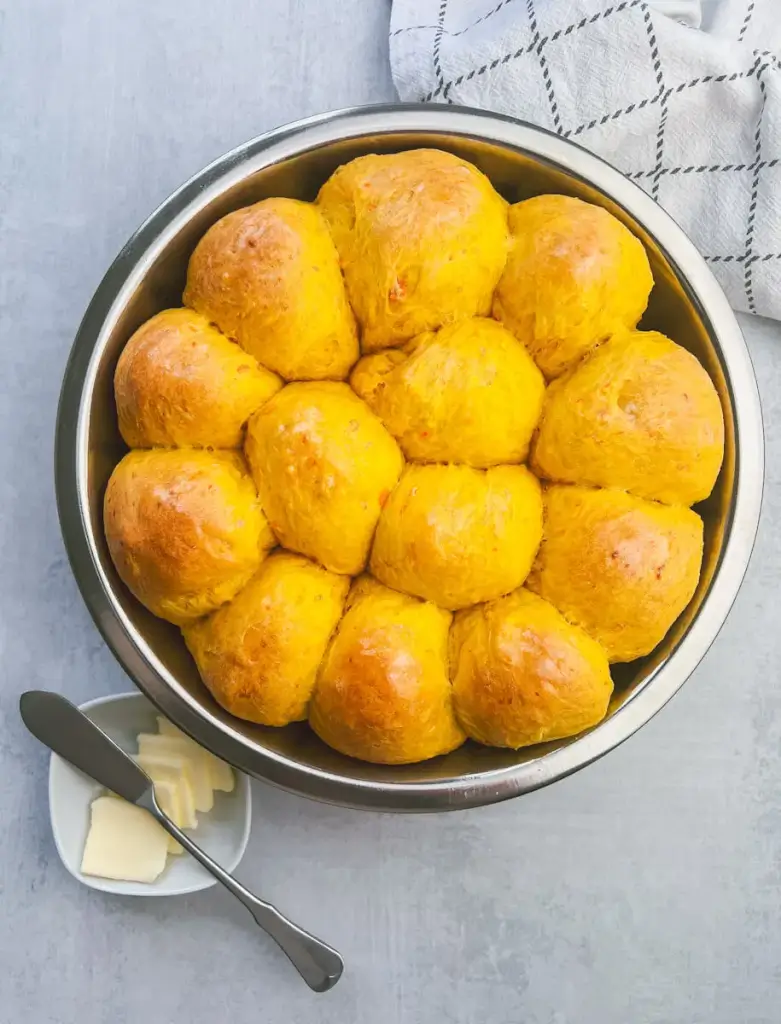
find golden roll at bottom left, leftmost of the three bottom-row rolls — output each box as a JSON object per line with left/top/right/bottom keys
{"left": 183, "top": 552, "right": 350, "bottom": 725}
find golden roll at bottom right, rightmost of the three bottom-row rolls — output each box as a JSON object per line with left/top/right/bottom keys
{"left": 450, "top": 589, "right": 613, "bottom": 750}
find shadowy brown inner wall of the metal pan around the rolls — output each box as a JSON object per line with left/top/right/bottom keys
{"left": 77, "top": 125, "right": 735, "bottom": 784}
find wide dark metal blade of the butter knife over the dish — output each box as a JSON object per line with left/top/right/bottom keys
{"left": 19, "top": 690, "right": 151, "bottom": 804}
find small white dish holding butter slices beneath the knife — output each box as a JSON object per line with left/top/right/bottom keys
{"left": 49, "top": 693, "right": 252, "bottom": 896}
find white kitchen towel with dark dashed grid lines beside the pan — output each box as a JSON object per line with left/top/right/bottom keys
{"left": 390, "top": 0, "right": 781, "bottom": 318}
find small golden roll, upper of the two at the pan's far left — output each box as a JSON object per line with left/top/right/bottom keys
{"left": 114, "top": 309, "right": 281, "bottom": 449}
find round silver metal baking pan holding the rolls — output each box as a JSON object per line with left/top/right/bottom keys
{"left": 55, "top": 105, "right": 764, "bottom": 811}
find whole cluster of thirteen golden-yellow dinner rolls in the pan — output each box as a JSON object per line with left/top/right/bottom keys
{"left": 104, "top": 150, "right": 724, "bottom": 764}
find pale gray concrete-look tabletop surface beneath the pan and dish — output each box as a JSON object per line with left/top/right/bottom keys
{"left": 0, "top": 0, "right": 781, "bottom": 1024}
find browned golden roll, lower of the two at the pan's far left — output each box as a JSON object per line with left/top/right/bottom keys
{"left": 103, "top": 449, "right": 274, "bottom": 626}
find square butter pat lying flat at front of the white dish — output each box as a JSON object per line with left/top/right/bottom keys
{"left": 81, "top": 797, "right": 168, "bottom": 882}
